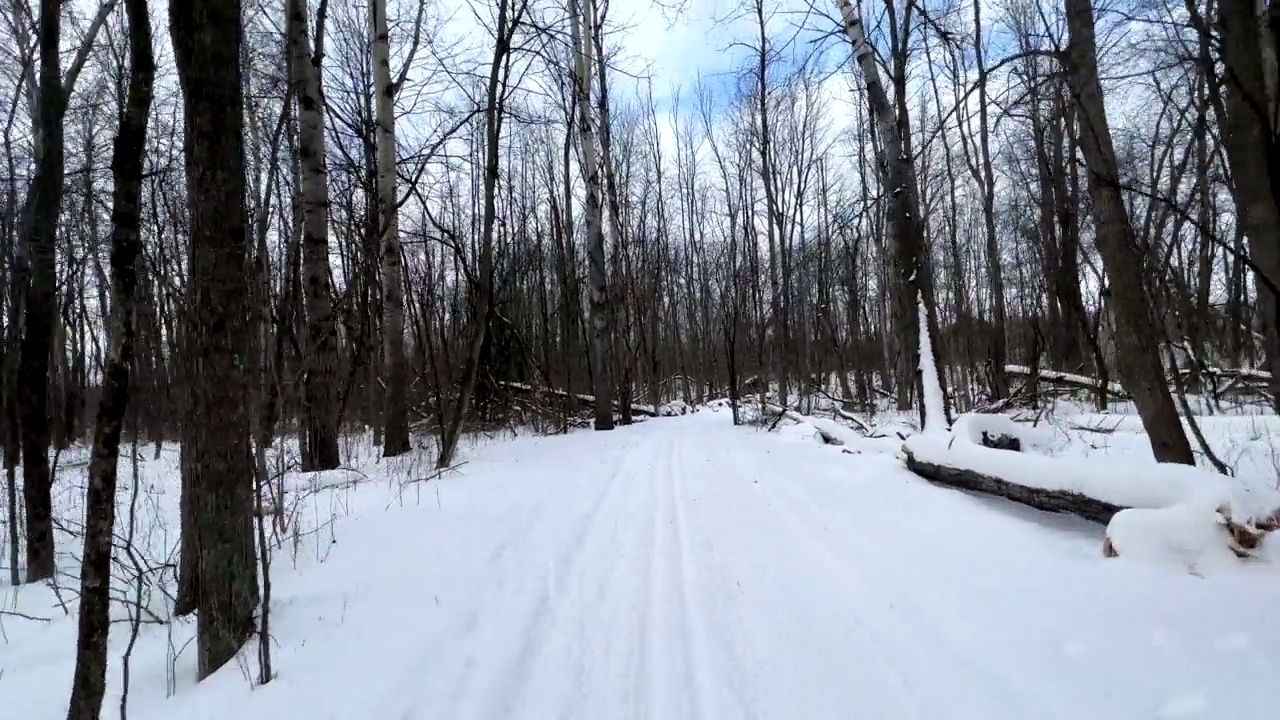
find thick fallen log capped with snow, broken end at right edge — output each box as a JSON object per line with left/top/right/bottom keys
{"left": 902, "top": 415, "right": 1280, "bottom": 568}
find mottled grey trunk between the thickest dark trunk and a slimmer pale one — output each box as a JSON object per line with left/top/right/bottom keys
{"left": 285, "top": 0, "right": 339, "bottom": 470}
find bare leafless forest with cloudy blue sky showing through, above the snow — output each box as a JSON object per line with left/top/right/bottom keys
{"left": 0, "top": 0, "right": 1280, "bottom": 720}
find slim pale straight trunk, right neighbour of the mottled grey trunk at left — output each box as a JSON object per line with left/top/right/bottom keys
{"left": 369, "top": 0, "right": 410, "bottom": 457}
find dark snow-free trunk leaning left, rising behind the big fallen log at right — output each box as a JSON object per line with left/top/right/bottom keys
{"left": 1065, "top": 0, "right": 1196, "bottom": 465}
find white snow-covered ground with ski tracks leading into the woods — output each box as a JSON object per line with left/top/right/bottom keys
{"left": 0, "top": 411, "right": 1280, "bottom": 720}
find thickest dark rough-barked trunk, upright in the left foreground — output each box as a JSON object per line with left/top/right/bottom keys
{"left": 169, "top": 0, "right": 259, "bottom": 679}
